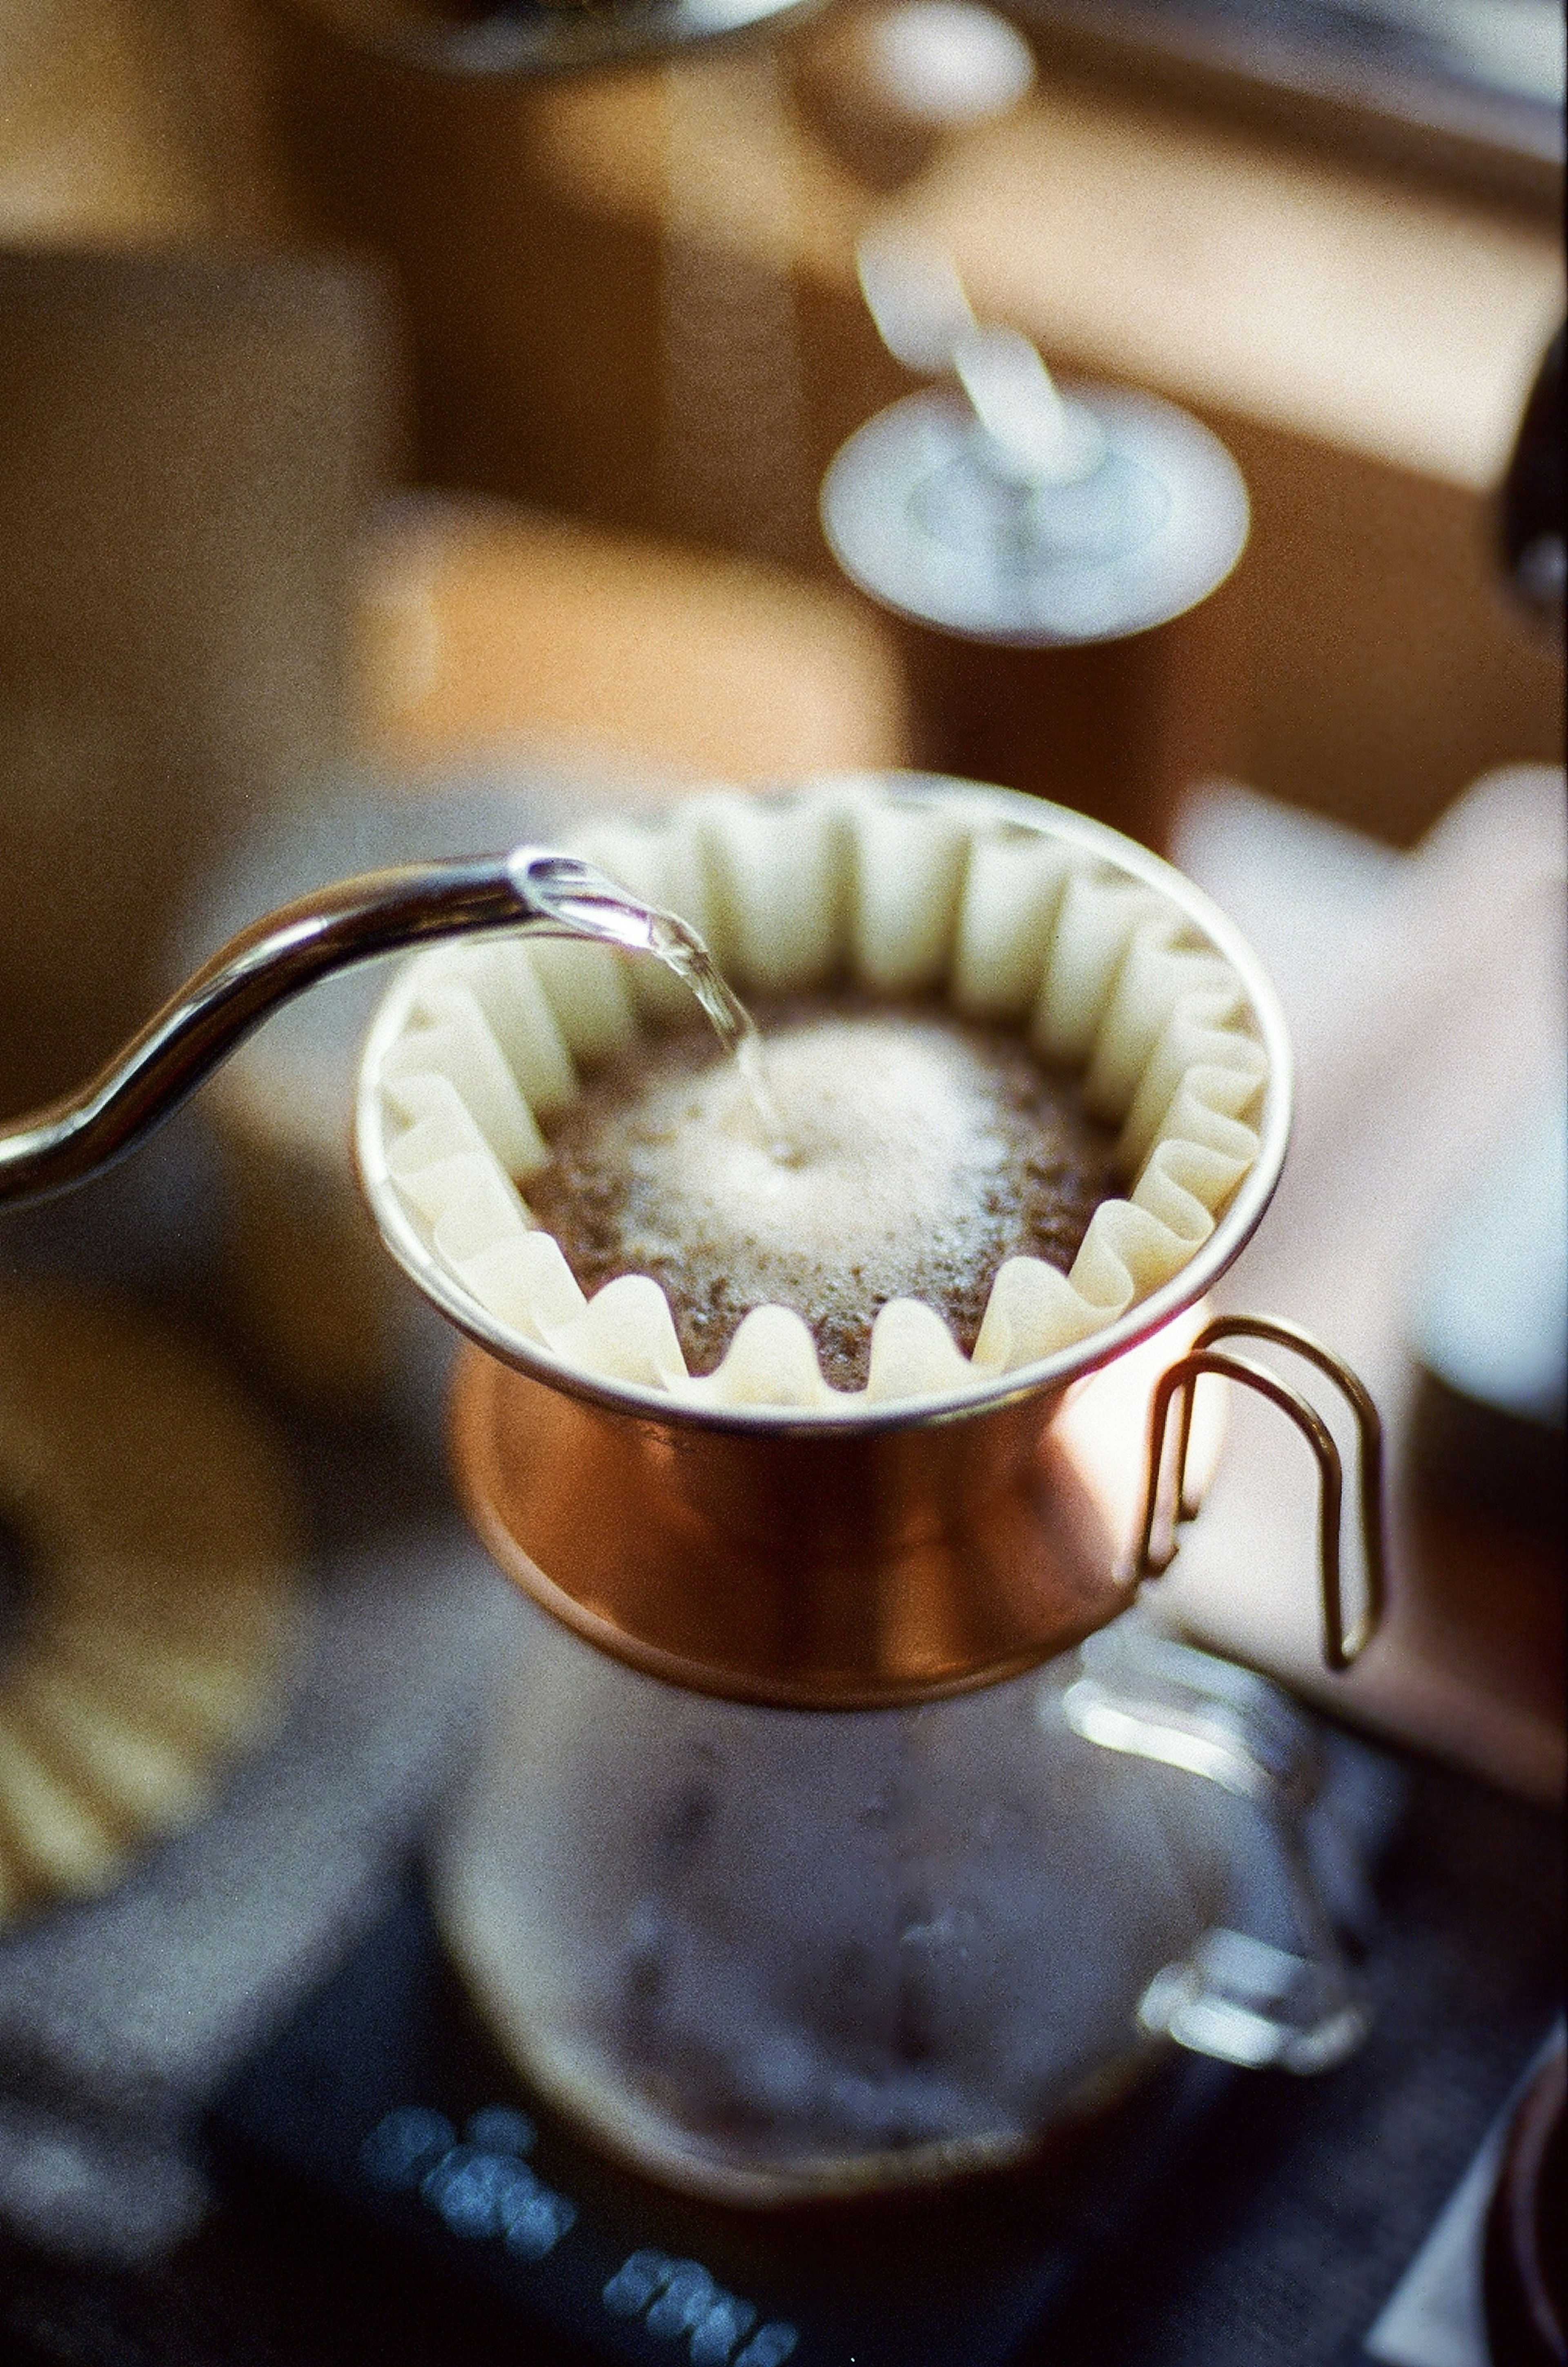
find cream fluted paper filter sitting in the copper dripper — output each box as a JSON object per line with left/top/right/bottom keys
{"left": 367, "top": 779, "right": 1267, "bottom": 1411}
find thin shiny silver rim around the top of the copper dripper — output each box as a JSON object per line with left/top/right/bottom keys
{"left": 355, "top": 771, "right": 1294, "bottom": 1439}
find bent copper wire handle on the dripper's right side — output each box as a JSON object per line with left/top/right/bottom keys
{"left": 1135, "top": 1316, "right": 1383, "bottom": 1671}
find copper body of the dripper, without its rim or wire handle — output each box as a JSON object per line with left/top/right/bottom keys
{"left": 452, "top": 1349, "right": 1128, "bottom": 1709}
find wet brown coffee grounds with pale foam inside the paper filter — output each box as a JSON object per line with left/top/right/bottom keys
{"left": 528, "top": 992, "right": 1119, "bottom": 1389}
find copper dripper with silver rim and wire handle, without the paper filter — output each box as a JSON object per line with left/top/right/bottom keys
{"left": 357, "top": 781, "right": 1381, "bottom": 1709}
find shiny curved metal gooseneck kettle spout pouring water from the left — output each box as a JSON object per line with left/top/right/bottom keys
{"left": 0, "top": 847, "right": 662, "bottom": 1205}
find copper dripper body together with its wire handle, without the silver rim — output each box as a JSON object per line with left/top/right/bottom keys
{"left": 452, "top": 1304, "right": 1383, "bottom": 1709}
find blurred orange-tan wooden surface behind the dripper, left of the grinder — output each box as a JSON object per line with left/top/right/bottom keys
{"left": 357, "top": 497, "right": 908, "bottom": 793}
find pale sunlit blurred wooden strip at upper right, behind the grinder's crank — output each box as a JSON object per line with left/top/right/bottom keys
{"left": 918, "top": 83, "right": 1561, "bottom": 493}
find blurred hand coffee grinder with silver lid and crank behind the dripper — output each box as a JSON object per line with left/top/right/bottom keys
{"left": 821, "top": 227, "right": 1251, "bottom": 847}
